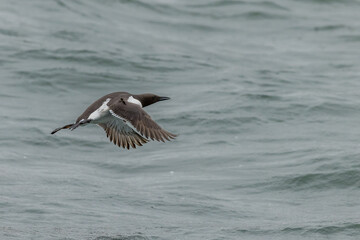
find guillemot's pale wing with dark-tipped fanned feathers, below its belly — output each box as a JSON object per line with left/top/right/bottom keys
{"left": 98, "top": 118, "right": 148, "bottom": 149}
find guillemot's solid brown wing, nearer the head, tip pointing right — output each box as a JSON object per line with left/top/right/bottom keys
{"left": 110, "top": 102, "right": 176, "bottom": 142}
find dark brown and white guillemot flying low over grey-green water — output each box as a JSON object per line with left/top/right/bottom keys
{"left": 51, "top": 92, "right": 176, "bottom": 149}
